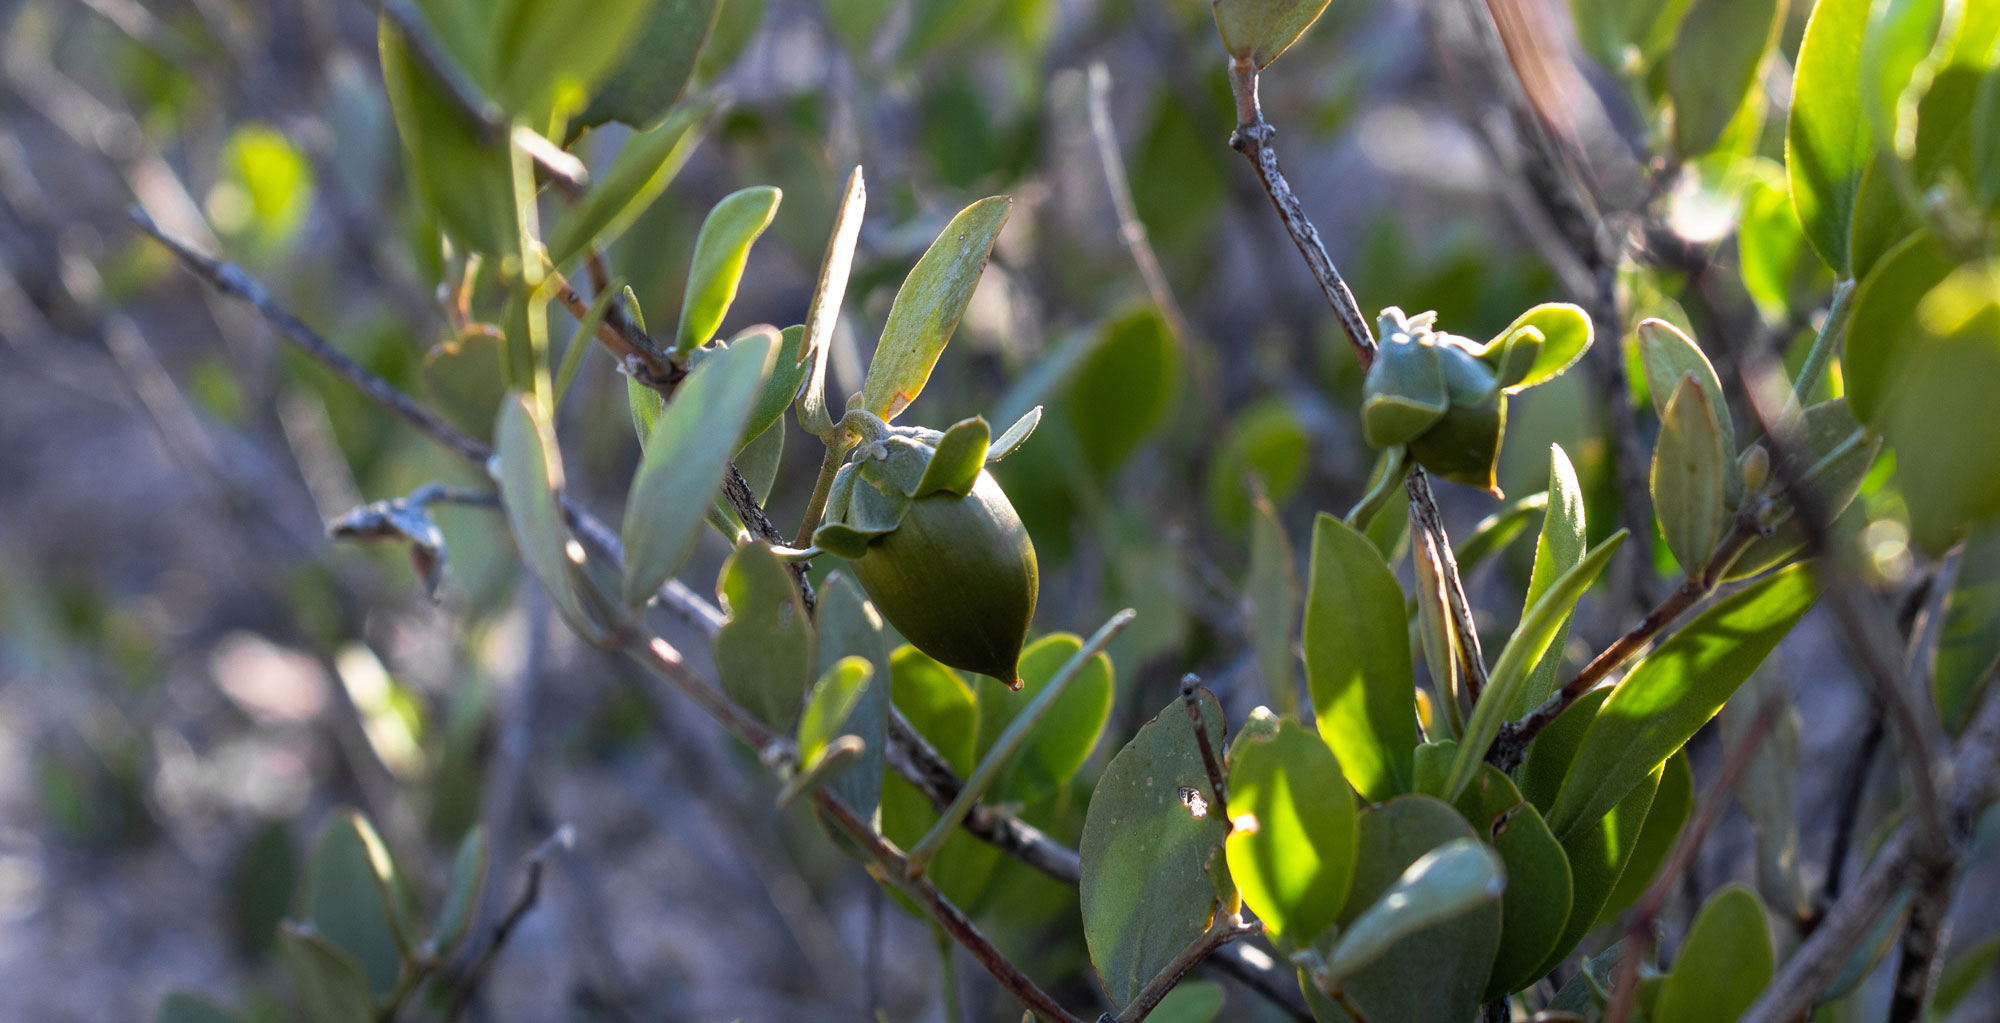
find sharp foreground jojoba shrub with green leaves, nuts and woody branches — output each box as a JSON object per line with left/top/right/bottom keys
{"left": 109, "top": 0, "right": 2000, "bottom": 1023}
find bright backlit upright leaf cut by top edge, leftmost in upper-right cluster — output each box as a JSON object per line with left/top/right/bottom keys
{"left": 1792, "top": 0, "right": 1874, "bottom": 271}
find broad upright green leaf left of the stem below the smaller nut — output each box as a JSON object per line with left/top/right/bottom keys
{"left": 1304, "top": 512, "right": 1416, "bottom": 801}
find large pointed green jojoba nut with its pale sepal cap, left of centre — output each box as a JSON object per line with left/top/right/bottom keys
{"left": 812, "top": 414, "right": 1040, "bottom": 687}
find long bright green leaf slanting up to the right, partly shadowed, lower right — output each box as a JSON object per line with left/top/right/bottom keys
{"left": 1548, "top": 565, "right": 1820, "bottom": 839}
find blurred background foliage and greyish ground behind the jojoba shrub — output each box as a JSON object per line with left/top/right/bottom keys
{"left": 0, "top": 0, "right": 1992, "bottom": 1021}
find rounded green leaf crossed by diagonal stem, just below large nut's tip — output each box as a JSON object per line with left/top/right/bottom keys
{"left": 980, "top": 631, "right": 1114, "bottom": 803}
